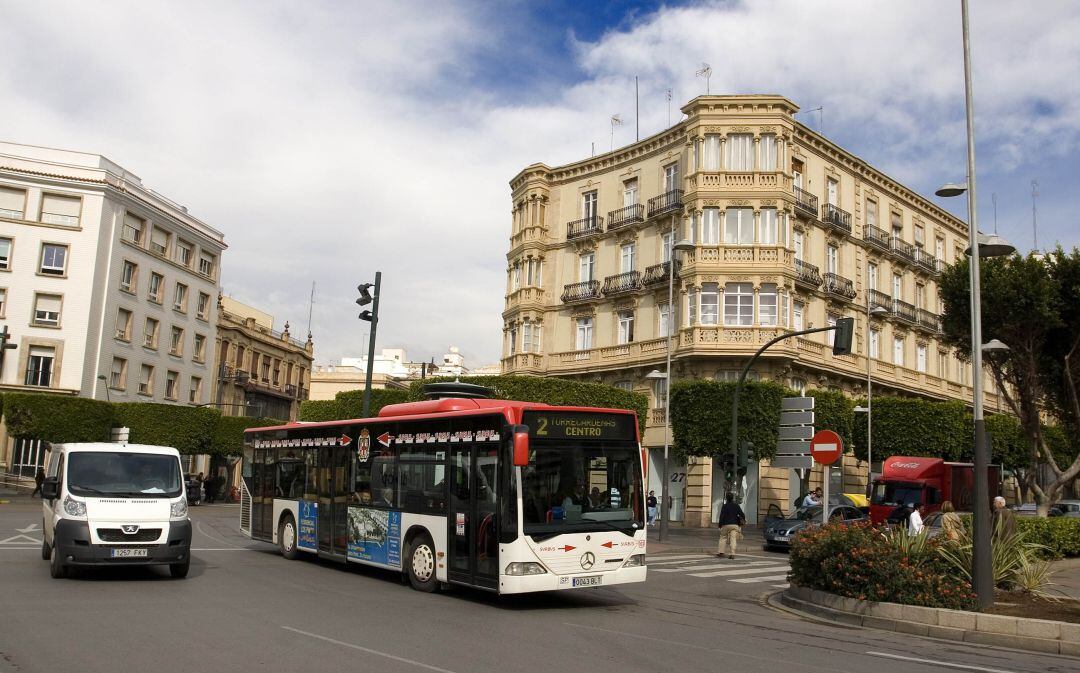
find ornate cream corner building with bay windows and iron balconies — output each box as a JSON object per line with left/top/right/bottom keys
{"left": 502, "top": 95, "right": 998, "bottom": 526}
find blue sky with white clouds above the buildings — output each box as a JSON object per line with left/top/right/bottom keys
{"left": 0, "top": 0, "right": 1080, "bottom": 365}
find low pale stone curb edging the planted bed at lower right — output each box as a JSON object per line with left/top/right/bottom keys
{"left": 769, "top": 587, "right": 1080, "bottom": 657}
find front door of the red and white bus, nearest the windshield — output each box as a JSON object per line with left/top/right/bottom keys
{"left": 447, "top": 442, "right": 499, "bottom": 589}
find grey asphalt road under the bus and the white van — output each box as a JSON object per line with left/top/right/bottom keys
{"left": 0, "top": 498, "right": 1080, "bottom": 673}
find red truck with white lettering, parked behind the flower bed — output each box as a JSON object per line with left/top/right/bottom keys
{"left": 870, "top": 456, "right": 1001, "bottom": 524}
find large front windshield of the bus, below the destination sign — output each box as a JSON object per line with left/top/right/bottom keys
{"left": 522, "top": 441, "right": 644, "bottom": 540}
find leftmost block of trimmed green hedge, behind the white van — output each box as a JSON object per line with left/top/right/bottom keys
{"left": 3, "top": 392, "right": 117, "bottom": 443}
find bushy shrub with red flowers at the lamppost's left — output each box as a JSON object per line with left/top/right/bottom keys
{"left": 791, "top": 523, "right": 976, "bottom": 610}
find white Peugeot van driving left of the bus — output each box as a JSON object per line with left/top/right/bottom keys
{"left": 41, "top": 442, "right": 191, "bottom": 578}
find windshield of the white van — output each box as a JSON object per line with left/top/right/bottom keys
{"left": 67, "top": 452, "right": 181, "bottom": 498}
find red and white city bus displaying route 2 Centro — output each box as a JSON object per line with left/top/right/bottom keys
{"left": 241, "top": 383, "right": 646, "bottom": 594}
